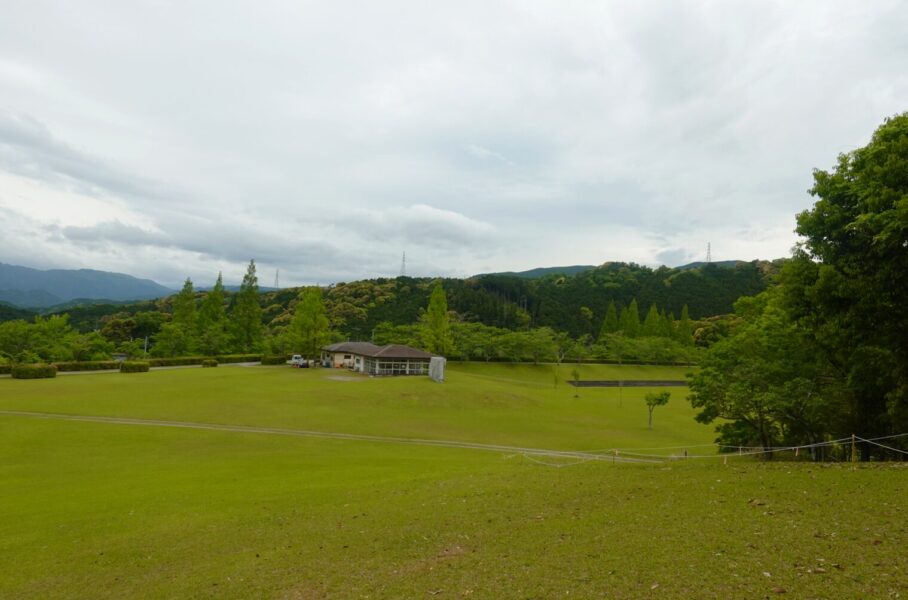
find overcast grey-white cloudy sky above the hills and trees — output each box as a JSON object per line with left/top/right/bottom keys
{"left": 0, "top": 0, "right": 908, "bottom": 286}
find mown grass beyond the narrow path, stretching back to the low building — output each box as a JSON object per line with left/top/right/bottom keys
{"left": 0, "top": 363, "right": 715, "bottom": 450}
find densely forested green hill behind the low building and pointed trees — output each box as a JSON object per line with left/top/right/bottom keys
{"left": 280, "top": 261, "right": 781, "bottom": 339}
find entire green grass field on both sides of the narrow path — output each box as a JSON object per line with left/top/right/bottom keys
{"left": 0, "top": 365, "right": 908, "bottom": 598}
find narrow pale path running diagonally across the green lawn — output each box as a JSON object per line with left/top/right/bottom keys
{"left": 0, "top": 410, "right": 662, "bottom": 463}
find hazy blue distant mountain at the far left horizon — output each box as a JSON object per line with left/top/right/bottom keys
{"left": 0, "top": 263, "right": 173, "bottom": 308}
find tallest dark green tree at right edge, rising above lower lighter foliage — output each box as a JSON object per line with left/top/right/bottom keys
{"left": 784, "top": 113, "right": 908, "bottom": 450}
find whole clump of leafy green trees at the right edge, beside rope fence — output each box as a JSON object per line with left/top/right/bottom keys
{"left": 691, "top": 113, "right": 908, "bottom": 460}
